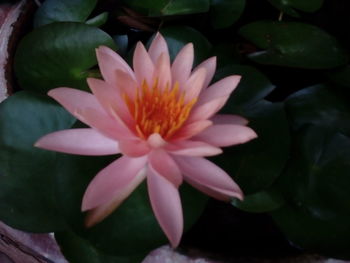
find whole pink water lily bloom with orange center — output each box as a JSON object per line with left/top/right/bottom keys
{"left": 35, "top": 33, "right": 257, "bottom": 250}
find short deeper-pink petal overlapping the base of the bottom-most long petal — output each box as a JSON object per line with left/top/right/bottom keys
{"left": 148, "top": 149, "right": 182, "bottom": 187}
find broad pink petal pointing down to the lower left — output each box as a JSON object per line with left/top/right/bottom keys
{"left": 81, "top": 156, "right": 147, "bottom": 211}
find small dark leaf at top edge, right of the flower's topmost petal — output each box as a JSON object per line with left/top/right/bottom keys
{"left": 210, "top": 0, "right": 245, "bottom": 28}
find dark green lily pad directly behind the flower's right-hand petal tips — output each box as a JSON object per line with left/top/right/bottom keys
{"left": 214, "top": 101, "right": 290, "bottom": 194}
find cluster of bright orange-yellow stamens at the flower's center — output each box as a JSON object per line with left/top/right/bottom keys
{"left": 124, "top": 80, "right": 197, "bottom": 139}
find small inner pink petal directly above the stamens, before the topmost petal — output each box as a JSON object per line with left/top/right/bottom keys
{"left": 153, "top": 53, "right": 172, "bottom": 90}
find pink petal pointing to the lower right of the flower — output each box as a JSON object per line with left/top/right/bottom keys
{"left": 174, "top": 156, "right": 243, "bottom": 200}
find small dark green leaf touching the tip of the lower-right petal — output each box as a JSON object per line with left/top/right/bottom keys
{"left": 232, "top": 190, "right": 285, "bottom": 213}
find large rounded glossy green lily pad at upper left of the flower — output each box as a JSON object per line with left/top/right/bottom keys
{"left": 15, "top": 22, "right": 114, "bottom": 92}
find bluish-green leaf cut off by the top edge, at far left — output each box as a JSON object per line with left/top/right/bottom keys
{"left": 34, "top": 0, "right": 97, "bottom": 27}
